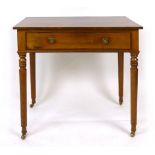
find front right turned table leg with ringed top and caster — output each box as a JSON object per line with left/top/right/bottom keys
{"left": 130, "top": 53, "right": 138, "bottom": 137}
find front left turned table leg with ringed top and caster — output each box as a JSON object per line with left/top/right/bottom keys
{"left": 18, "top": 52, "right": 27, "bottom": 139}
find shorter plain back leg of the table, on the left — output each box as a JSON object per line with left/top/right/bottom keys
{"left": 30, "top": 53, "right": 36, "bottom": 108}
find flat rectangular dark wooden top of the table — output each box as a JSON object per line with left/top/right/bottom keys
{"left": 13, "top": 16, "right": 143, "bottom": 29}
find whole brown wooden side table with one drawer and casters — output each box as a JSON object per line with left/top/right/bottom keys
{"left": 13, "top": 17, "right": 143, "bottom": 139}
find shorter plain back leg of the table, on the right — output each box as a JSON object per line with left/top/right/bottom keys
{"left": 118, "top": 52, "right": 124, "bottom": 105}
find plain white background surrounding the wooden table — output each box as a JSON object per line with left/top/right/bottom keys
{"left": 0, "top": 0, "right": 155, "bottom": 155}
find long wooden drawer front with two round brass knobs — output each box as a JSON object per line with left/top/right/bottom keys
{"left": 26, "top": 32, "right": 130, "bottom": 50}
